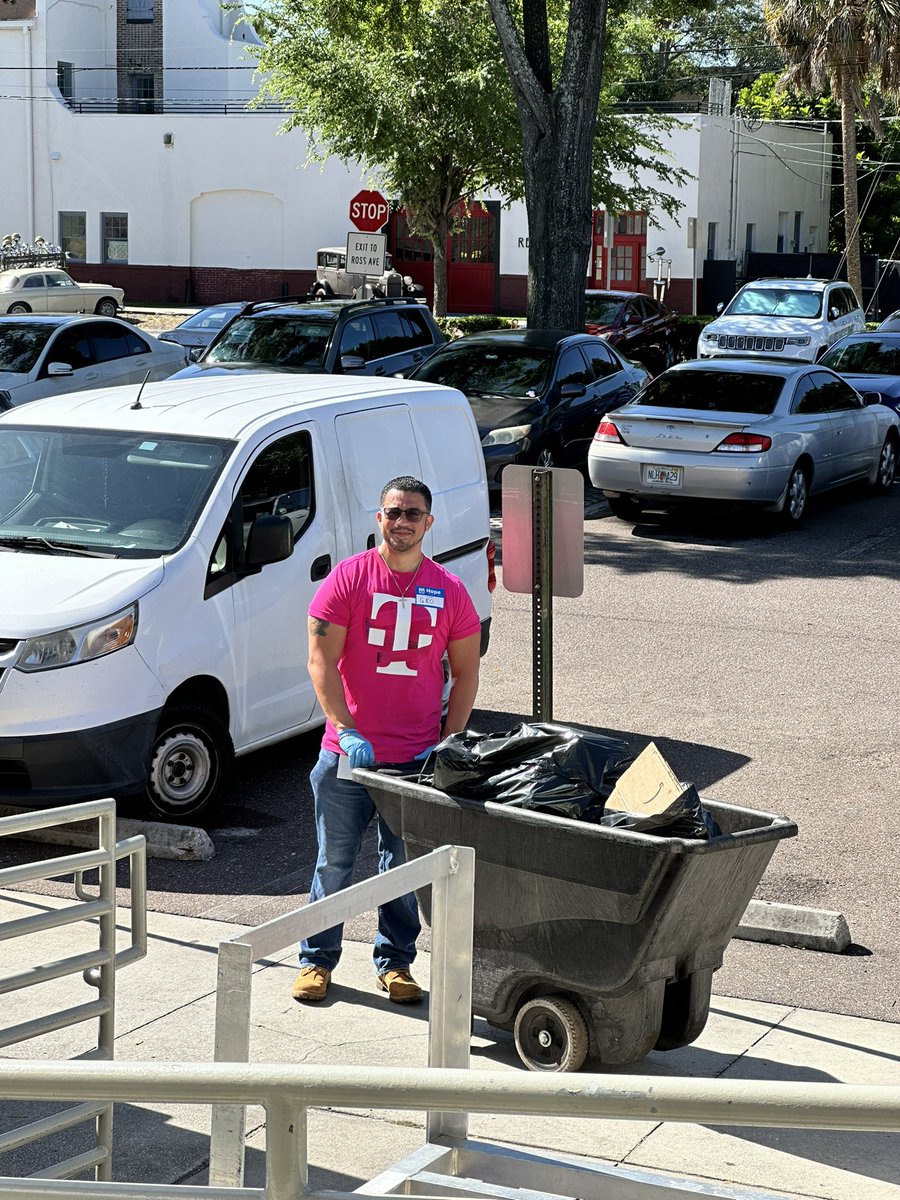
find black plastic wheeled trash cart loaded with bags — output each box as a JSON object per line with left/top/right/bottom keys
{"left": 354, "top": 770, "right": 797, "bottom": 1072}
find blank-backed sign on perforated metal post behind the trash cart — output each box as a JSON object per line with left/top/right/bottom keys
{"left": 503, "top": 466, "right": 584, "bottom": 721}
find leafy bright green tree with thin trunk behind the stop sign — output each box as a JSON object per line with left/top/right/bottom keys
{"left": 253, "top": 0, "right": 517, "bottom": 314}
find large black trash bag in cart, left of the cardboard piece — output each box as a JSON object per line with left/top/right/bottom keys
{"left": 421, "top": 722, "right": 634, "bottom": 821}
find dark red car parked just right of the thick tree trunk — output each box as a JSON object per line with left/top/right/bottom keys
{"left": 584, "top": 288, "right": 678, "bottom": 372}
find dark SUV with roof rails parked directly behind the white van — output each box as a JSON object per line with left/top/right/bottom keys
{"left": 172, "top": 296, "right": 446, "bottom": 379}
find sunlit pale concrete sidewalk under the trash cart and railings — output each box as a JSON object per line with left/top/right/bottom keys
{"left": 0, "top": 892, "right": 900, "bottom": 1200}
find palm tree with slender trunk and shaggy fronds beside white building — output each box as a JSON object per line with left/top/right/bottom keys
{"left": 763, "top": 0, "right": 900, "bottom": 298}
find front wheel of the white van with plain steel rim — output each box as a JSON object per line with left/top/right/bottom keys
{"left": 146, "top": 704, "right": 234, "bottom": 821}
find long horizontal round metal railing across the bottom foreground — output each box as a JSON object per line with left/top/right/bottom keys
{"left": 0, "top": 1062, "right": 900, "bottom": 1200}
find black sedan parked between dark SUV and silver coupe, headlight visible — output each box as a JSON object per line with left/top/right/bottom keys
{"left": 412, "top": 329, "right": 650, "bottom": 487}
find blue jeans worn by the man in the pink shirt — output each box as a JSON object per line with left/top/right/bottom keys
{"left": 300, "top": 750, "right": 421, "bottom": 974}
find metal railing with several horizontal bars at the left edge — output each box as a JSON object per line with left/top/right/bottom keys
{"left": 0, "top": 800, "right": 146, "bottom": 1182}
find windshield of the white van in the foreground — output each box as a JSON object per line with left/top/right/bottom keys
{"left": 0, "top": 421, "right": 235, "bottom": 558}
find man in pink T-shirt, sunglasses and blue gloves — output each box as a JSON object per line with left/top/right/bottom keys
{"left": 292, "top": 475, "right": 481, "bottom": 1003}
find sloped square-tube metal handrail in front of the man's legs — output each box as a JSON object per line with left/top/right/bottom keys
{"left": 209, "top": 846, "right": 475, "bottom": 1188}
